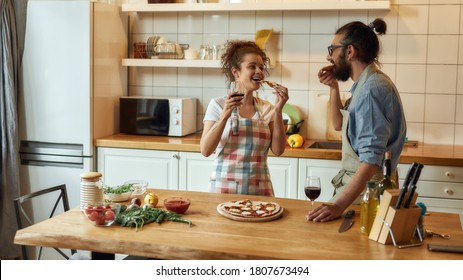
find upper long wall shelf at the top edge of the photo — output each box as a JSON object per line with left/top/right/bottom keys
{"left": 122, "top": 0, "right": 390, "bottom": 12}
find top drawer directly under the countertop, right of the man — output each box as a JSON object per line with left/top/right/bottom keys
{"left": 397, "top": 164, "right": 463, "bottom": 183}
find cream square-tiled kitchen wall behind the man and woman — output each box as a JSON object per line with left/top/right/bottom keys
{"left": 129, "top": 0, "right": 463, "bottom": 145}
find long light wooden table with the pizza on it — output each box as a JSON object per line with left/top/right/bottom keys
{"left": 14, "top": 189, "right": 463, "bottom": 260}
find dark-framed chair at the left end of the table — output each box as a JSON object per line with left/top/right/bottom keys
{"left": 13, "top": 184, "right": 77, "bottom": 260}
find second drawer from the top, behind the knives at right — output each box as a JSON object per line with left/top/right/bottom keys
{"left": 416, "top": 180, "right": 463, "bottom": 200}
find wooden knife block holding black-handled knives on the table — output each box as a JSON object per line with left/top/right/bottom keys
{"left": 369, "top": 189, "right": 421, "bottom": 244}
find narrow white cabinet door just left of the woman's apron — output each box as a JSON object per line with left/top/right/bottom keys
{"left": 179, "top": 152, "right": 214, "bottom": 192}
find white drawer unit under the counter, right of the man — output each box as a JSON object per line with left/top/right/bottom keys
{"left": 398, "top": 164, "right": 463, "bottom": 225}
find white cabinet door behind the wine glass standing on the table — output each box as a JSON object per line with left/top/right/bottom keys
{"left": 297, "top": 159, "right": 341, "bottom": 202}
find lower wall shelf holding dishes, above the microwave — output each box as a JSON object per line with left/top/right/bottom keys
{"left": 122, "top": 58, "right": 220, "bottom": 68}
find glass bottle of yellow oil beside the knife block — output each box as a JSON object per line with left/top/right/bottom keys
{"left": 360, "top": 181, "right": 379, "bottom": 236}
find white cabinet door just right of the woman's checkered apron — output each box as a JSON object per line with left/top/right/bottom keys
{"left": 267, "top": 157, "right": 298, "bottom": 198}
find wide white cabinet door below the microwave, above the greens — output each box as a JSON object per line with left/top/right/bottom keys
{"left": 97, "top": 147, "right": 179, "bottom": 189}
